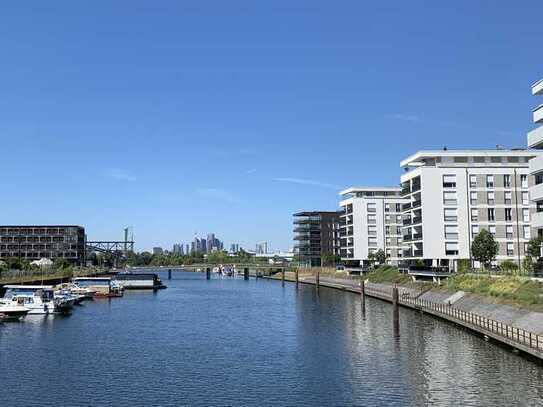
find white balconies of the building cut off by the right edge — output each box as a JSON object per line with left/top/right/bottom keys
{"left": 528, "top": 79, "right": 543, "bottom": 236}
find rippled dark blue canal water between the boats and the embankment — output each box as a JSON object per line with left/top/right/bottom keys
{"left": 0, "top": 273, "right": 543, "bottom": 406}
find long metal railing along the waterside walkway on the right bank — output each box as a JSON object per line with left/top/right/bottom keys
{"left": 364, "top": 286, "right": 543, "bottom": 352}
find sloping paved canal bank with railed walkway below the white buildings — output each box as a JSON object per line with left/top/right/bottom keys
{"left": 270, "top": 273, "right": 543, "bottom": 362}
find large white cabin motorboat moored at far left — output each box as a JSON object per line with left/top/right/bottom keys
{"left": 1, "top": 285, "right": 55, "bottom": 315}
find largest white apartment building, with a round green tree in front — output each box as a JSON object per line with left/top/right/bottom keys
{"left": 400, "top": 149, "right": 539, "bottom": 269}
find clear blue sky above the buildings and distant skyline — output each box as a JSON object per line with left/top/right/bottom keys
{"left": 0, "top": 0, "right": 543, "bottom": 249}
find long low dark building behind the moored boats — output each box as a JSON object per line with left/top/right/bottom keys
{"left": 0, "top": 225, "right": 85, "bottom": 265}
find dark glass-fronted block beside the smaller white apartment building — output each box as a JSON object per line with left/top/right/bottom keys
{"left": 293, "top": 211, "right": 339, "bottom": 267}
